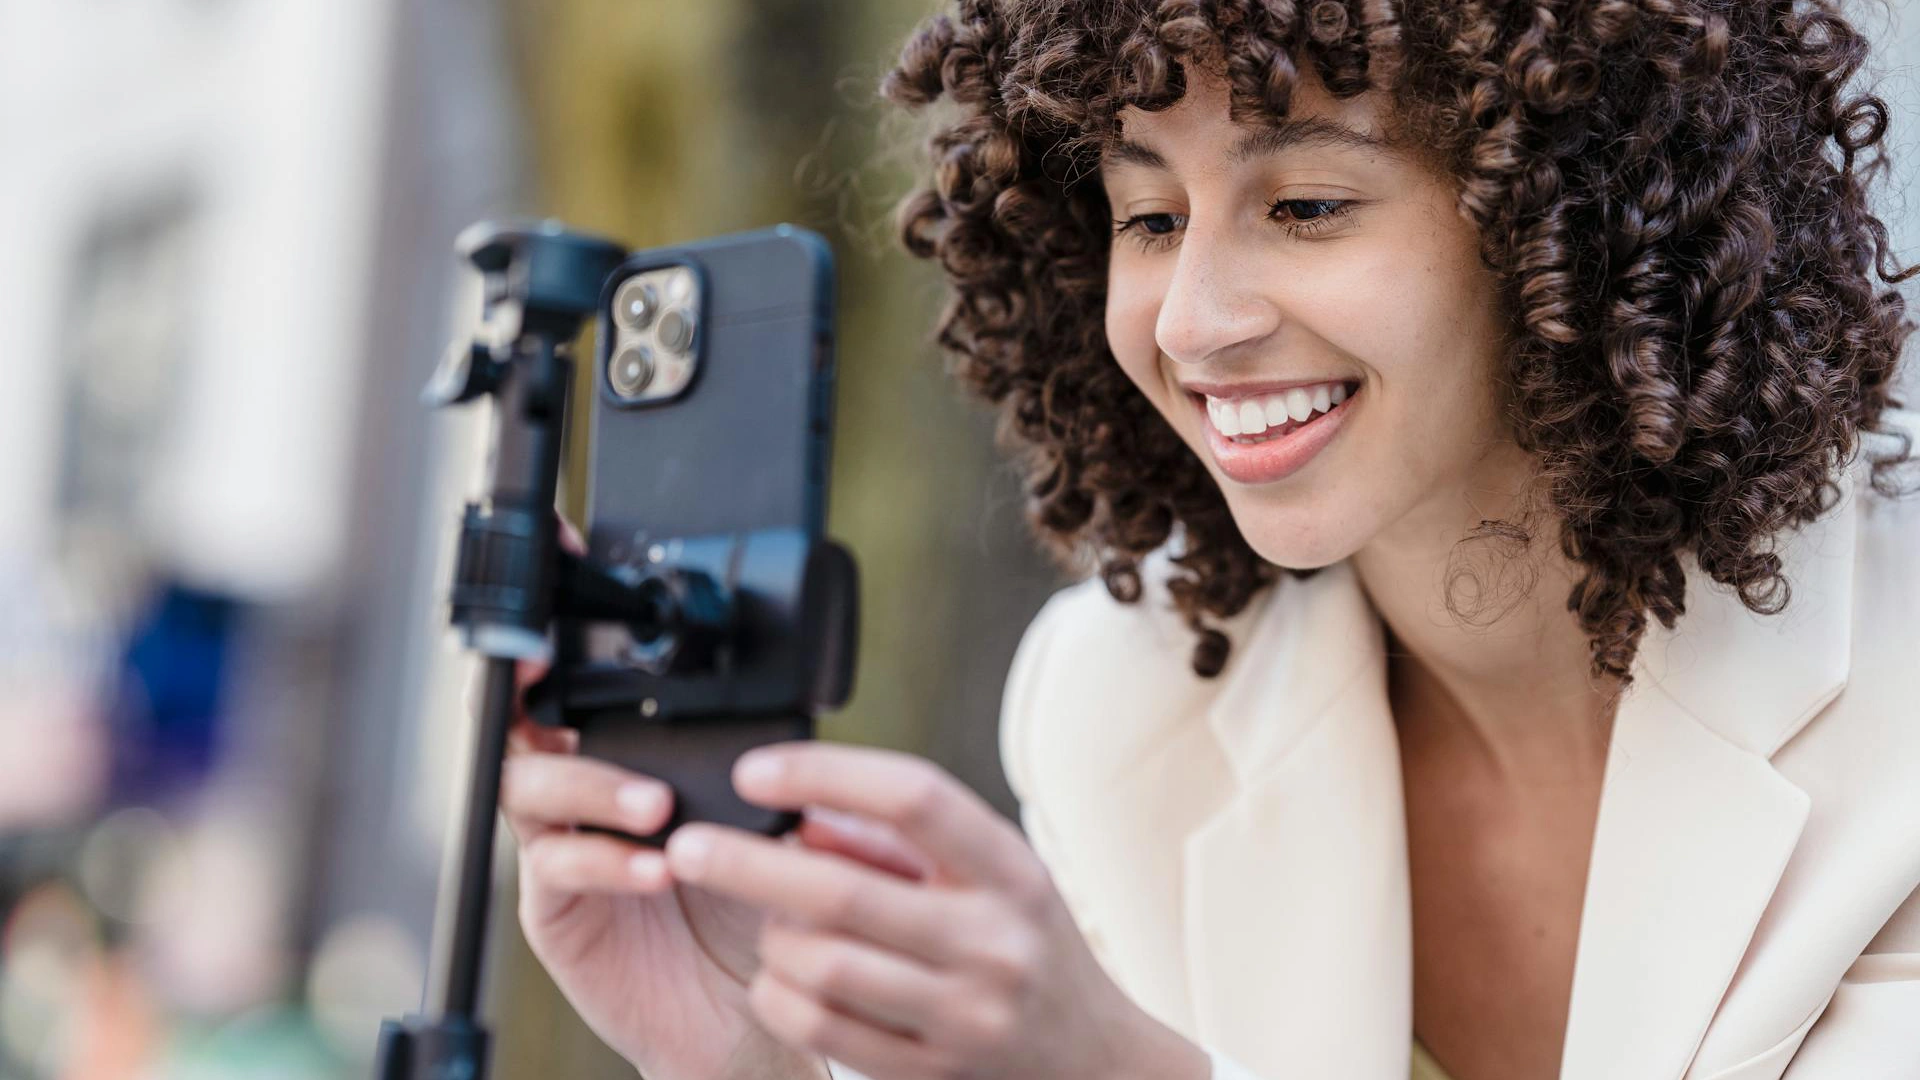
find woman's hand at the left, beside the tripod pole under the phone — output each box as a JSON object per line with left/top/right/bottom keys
{"left": 501, "top": 518, "right": 920, "bottom": 1080}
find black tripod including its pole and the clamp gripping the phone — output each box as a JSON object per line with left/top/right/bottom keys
{"left": 376, "top": 223, "right": 858, "bottom": 1080}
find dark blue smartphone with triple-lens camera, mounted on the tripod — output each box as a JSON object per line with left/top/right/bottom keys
{"left": 529, "top": 225, "right": 856, "bottom": 846}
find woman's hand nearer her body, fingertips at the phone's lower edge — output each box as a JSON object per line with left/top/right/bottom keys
{"left": 666, "top": 742, "right": 1210, "bottom": 1080}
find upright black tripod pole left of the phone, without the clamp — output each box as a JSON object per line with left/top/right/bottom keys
{"left": 374, "top": 225, "right": 626, "bottom": 1080}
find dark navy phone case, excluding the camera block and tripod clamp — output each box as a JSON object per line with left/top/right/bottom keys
{"left": 555, "top": 225, "right": 833, "bottom": 846}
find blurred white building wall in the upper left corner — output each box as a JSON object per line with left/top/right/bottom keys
{"left": 0, "top": 0, "right": 394, "bottom": 600}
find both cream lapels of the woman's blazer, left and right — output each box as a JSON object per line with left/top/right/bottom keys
{"left": 1183, "top": 468, "right": 1857, "bottom": 1080}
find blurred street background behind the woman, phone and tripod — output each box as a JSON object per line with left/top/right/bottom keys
{"left": 0, "top": 0, "right": 1920, "bottom": 1080}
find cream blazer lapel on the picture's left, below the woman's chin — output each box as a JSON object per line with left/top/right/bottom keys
{"left": 1185, "top": 563, "right": 1411, "bottom": 1080}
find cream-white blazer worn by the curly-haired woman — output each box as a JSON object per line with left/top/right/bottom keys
{"left": 1000, "top": 413, "right": 1920, "bottom": 1080}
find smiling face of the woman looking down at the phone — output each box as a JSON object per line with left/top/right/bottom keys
{"left": 1100, "top": 65, "right": 1513, "bottom": 569}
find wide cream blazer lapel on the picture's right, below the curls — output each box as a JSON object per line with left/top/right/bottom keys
{"left": 1561, "top": 472, "right": 1855, "bottom": 1080}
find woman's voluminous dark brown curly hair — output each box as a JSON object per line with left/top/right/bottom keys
{"left": 881, "top": 0, "right": 1920, "bottom": 680}
